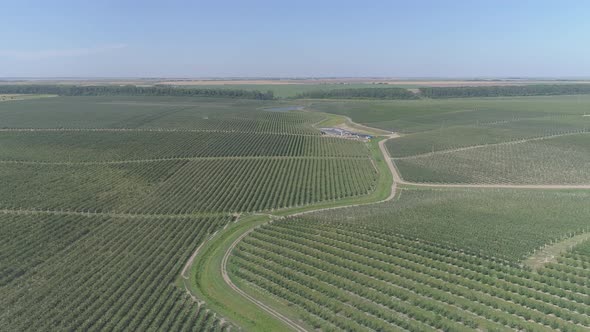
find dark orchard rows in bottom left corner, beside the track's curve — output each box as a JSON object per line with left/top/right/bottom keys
{"left": 0, "top": 215, "right": 230, "bottom": 331}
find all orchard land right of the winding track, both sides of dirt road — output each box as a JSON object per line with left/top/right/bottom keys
{"left": 224, "top": 92, "right": 590, "bottom": 331}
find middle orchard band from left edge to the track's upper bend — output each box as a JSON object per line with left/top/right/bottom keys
{"left": 0, "top": 157, "right": 378, "bottom": 214}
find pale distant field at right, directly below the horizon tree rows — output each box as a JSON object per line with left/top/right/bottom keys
{"left": 308, "top": 95, "right": 590, "bottom": 136}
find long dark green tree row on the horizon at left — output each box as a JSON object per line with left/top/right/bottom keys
{"left": 0, "top": 84, "right": 274, "bottom": 100}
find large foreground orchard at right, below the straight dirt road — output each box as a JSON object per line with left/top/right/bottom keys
{"left": 229, "top": 186, "right": 590, "bottom": 331}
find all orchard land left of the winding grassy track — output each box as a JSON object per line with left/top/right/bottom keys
{"left": 0, "top": 96, "right": 382, "bottom": 331}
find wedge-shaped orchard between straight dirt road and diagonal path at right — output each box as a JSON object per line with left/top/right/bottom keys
{"left": 395, "top": 133, "right": 590, "bottom": 184}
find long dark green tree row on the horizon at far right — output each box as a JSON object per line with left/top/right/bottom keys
{"left": 420, "top": 84, "right": 590, "bottom": 98}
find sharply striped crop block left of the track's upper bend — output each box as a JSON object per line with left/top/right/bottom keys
{"left": 130, "top": 158, "right": 377, "bottom": 214}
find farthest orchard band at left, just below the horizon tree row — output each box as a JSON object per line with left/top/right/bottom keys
{"left": 0, "top": 97, "right": 322, "bottom": 135}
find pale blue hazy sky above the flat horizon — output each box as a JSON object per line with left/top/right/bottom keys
{"left": 0, "top": 0, "right": 590, "bottom": 77}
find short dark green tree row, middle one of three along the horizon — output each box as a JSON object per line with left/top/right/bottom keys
{"left": 296, "top": 88, "right": 418, "bottom": 99}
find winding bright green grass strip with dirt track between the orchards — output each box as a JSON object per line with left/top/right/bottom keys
{"left": 187, "top": 113, "right": 396, "bottom": 331}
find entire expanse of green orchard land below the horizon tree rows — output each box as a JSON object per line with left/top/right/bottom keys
{"left": 0, "top": 92, "right": 590, "bottom": 331}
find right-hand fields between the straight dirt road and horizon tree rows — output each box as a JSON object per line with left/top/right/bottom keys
{"left": 308, "top": 95, "right": 590, "bottom": 185}
